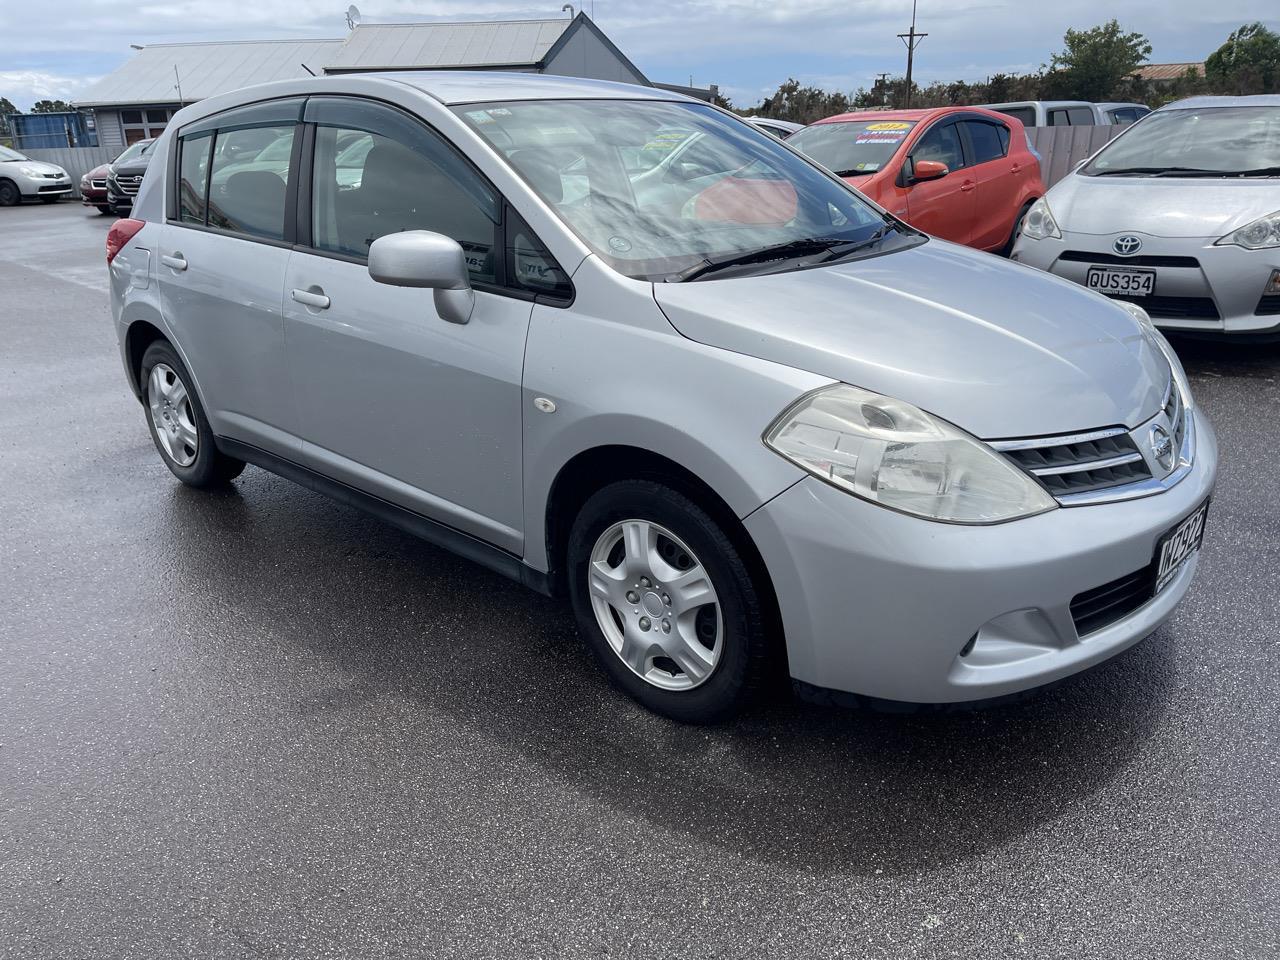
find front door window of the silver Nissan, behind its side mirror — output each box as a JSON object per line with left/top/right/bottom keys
{"left": 308, "top": 101, "right": 499, "bottom": 289}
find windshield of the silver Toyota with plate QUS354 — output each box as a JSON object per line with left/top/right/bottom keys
{"left": 1082, "top": 106, "right": 1280, "bottom": 177}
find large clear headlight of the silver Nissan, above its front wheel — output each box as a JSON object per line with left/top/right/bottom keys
{"left": 764, "top": 384, "right": 1057, "bottom": 524}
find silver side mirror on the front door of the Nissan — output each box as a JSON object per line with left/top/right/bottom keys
{"left": 369, "top": 230, "right": 476, "bottom": 324}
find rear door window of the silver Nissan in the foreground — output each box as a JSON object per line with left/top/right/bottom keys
{"left": 209, "top": 124, "right": 297, "bottom": 239}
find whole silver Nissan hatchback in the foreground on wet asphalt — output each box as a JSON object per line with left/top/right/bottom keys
{"left": 108, "top": 72, "right": 1217, "bottom": 721}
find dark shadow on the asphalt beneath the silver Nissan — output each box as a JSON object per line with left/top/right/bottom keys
{"left": 152, "top": 468, "right": 1178, "bottom": 874}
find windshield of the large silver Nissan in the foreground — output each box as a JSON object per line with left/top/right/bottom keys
{"left": 454, "top": 100, "right": 919, "bottom": 280}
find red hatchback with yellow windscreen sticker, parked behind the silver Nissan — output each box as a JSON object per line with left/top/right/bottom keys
{"left": 787, "top": 106, "right": 1044, "bottom": 251}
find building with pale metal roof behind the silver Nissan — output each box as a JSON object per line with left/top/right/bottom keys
{"left": 77, "top": 13, "right": 665, "bottom": 148}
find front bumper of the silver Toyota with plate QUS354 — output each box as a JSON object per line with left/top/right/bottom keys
{"left": 1012, "top": 230, "right": 1280, "bottom": 334}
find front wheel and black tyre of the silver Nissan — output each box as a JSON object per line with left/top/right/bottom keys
{"left": 567, "top": 480, "right": 769, "bottom": 723}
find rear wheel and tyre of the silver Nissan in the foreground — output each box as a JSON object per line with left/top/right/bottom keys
{"left": 140, "top": 340, "right": 244, "bottom": 488}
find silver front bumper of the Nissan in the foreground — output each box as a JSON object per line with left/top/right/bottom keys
{"left": 746, "top": 411, "right": 1217, "bottom": 704}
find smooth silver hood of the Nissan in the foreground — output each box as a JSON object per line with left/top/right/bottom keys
{"left": 654, "top": 239, "right": 1169, "bottom": 439}
